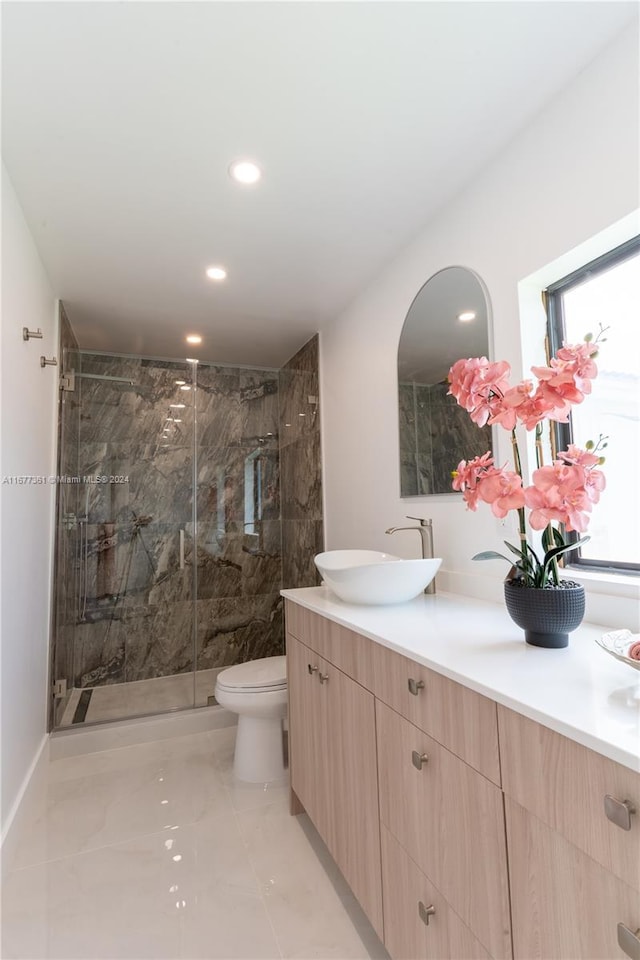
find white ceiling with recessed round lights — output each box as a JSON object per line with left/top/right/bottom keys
{"left": 2, "top": 0, "right": 637, "bottom": 365}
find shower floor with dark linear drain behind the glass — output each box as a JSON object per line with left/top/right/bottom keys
{"left": 60, "top": 667, "right": 222, "bottom": 727}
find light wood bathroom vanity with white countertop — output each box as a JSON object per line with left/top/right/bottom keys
{"left": 283, "top": 587, "right": 640, "bottom": 960}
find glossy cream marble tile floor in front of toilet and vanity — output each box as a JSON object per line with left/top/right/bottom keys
{"left": 1, "top": 727, "right": 387, "bottom": 960}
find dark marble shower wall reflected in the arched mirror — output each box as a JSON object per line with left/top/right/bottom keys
{"left": 399, "top": 383, "right": 491, "bottom": 497}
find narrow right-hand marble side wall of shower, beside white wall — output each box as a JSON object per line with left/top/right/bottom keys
{"left": 279, "top": 334, "right": 324, "bottom": 588}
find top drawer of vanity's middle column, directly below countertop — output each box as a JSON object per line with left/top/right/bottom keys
{"left": 372, "top": 643, "right": 500, "bottom": 786}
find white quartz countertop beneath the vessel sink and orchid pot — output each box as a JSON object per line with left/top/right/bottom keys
{"left": 281, "top": 586, "right": 640, "bottom": 770}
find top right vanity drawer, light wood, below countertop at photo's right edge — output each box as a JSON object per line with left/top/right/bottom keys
{"left": 498, "top": 706, "right": 640, "bottom": 890}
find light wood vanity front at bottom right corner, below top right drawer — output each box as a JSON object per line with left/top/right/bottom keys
{"left": 505, "top": 797, "right": 640, "bottom": 960}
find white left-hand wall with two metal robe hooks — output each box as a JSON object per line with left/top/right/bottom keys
{"left": 0, "top": 166, "right": 58, "bottom": 838}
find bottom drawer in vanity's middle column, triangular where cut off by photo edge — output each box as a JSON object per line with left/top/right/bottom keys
{"left": 381, "top": 826, "right": 491, "bottom": 960}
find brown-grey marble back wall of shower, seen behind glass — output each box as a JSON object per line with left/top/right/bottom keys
{"left": 70, "top": 354, "right": 283, "bottom": 686}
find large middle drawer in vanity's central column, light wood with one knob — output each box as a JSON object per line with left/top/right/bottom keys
{"left": 376, "top": 701, "right": 511, "bottom": 960}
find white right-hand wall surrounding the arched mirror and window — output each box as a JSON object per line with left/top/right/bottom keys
{"left": 321, "top": 24, "right": 639, "bottom": 627}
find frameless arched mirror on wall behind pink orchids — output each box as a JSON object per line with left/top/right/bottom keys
{"left": 398, "top": 267, "right": 491, "bottom": 497}
